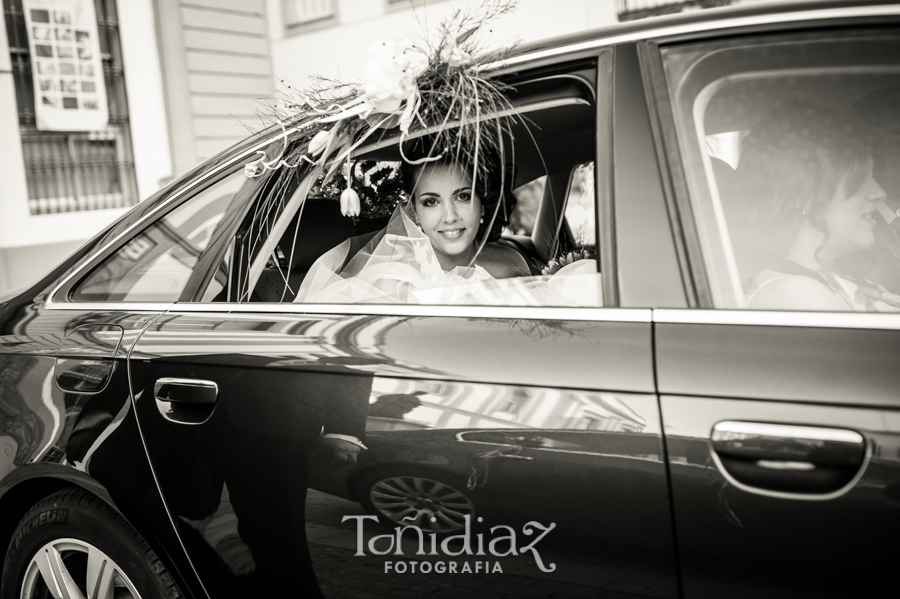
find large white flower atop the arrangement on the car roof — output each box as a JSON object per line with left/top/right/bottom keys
{"left": 363, "top": 40, "right": 428, "bottom": 112}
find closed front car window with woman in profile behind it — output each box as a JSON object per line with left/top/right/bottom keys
{"left": 662, "top": 29, "right": 900, "bottom": 312}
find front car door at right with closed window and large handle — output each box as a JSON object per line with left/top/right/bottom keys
{"left": 642, "top": 18, "right": 900, "bottom": 597}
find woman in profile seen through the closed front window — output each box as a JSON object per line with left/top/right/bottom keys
{"left": 737, "top": 102, "right": 900, "bottom": 312}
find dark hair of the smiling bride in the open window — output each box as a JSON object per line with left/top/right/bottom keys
{"left": 400, "top": 146, "right": 517, "bottom": 241}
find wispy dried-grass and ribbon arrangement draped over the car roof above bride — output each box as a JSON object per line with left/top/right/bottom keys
{"left": 239, "top": 0, "right": 521, "bottom": 299}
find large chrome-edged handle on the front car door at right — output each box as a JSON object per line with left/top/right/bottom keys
{"left": 711, "top": 420, "right": 867, "bottom": 496}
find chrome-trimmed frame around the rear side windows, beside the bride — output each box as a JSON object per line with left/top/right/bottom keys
{"left": 47, "top": 53, "right": 632, "bottom": 323}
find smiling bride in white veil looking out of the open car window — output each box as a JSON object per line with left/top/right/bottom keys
{"left": 294, "top": 152, "right": 596, "bottom": 305}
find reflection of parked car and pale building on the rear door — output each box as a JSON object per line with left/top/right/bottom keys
{"left": 310, "top": 377, "right": 661, "bottom": 542}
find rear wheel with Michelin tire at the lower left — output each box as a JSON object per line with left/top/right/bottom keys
{"left": 0, "top": 487, "right": 184, "bottom": 599}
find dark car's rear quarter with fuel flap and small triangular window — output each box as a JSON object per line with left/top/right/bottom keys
{"left": 0, "top": 146, "right": 260, "bottom": 592}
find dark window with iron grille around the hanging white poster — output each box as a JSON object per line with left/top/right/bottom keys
{"left": 3, "top": 0, "right": 140, "bottom": 215}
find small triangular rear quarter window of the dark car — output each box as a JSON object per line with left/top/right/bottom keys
{"left": 71, "top": 170, "right": 248, "bottom": 302}
